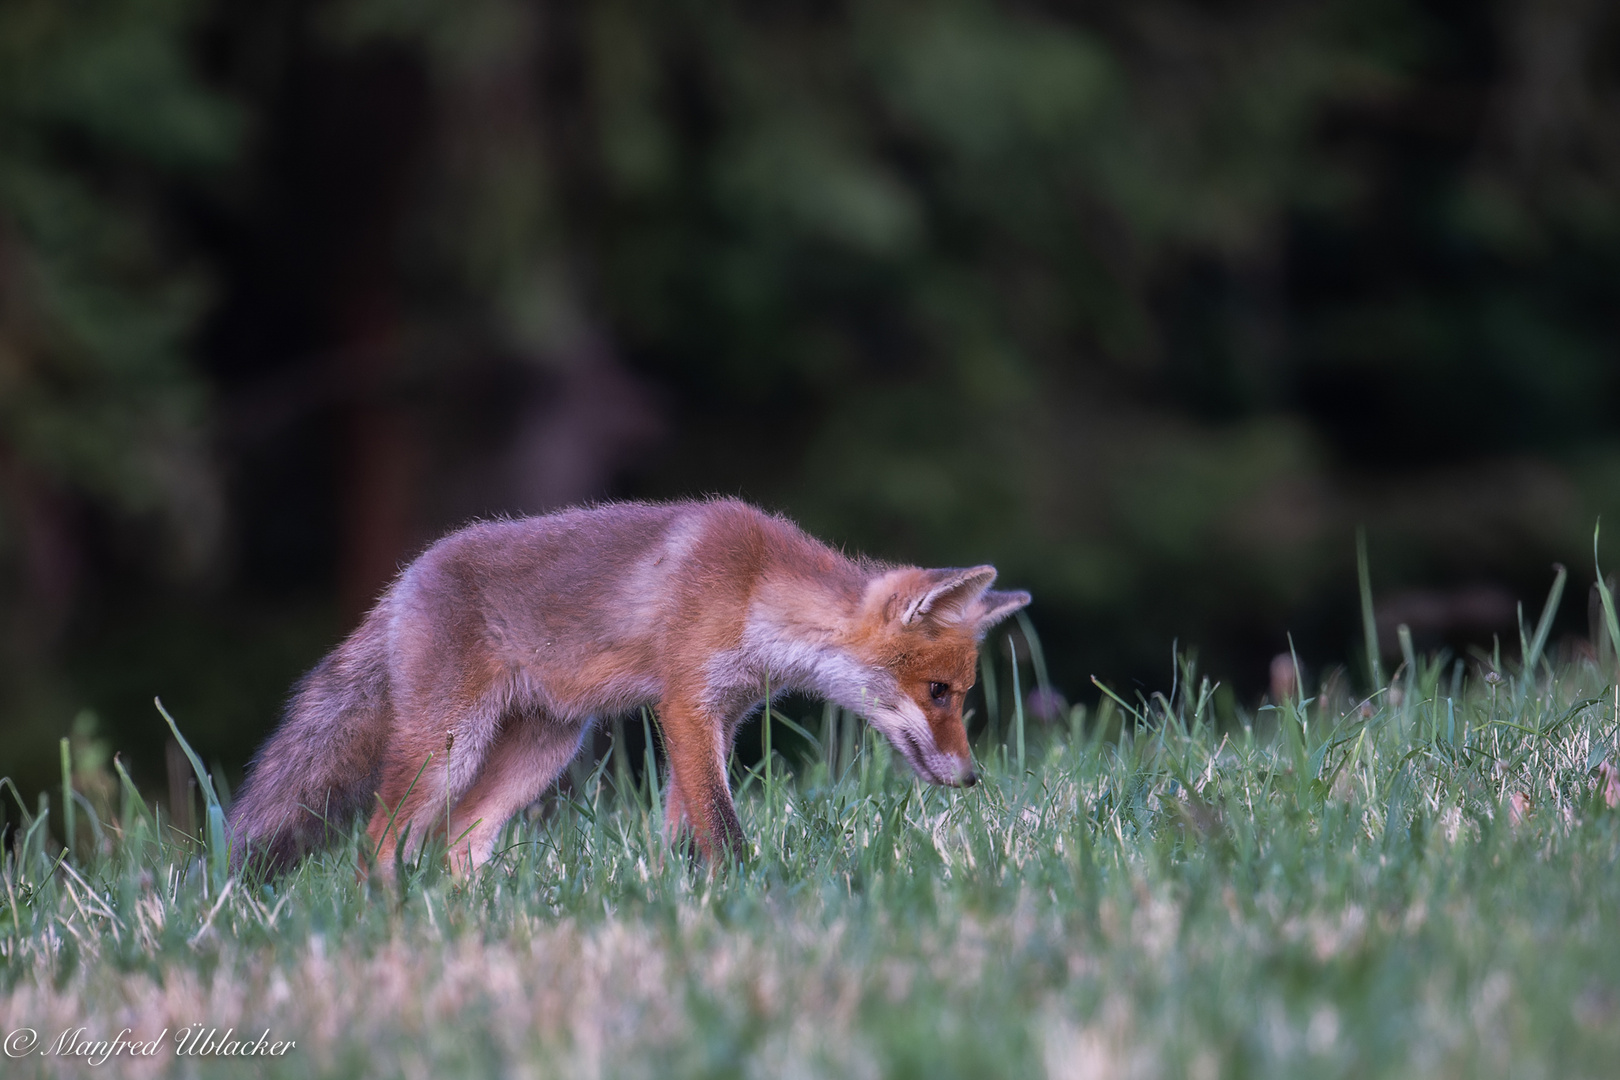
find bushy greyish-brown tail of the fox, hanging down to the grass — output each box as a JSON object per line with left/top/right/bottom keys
{"left": 225, "top": 606, "right": 392, "bottom": 873}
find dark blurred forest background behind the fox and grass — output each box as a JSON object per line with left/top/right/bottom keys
{"left": 0, "top": 0, "right": 1620, "bottom": 809}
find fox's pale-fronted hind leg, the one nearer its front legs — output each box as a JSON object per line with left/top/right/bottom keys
{"left": 447, "top": 709, "right": 590, "bottom": 873}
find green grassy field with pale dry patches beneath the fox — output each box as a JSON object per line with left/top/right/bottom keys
{"left": 0, "top": 612, "right": 1620, "bottom": 1078}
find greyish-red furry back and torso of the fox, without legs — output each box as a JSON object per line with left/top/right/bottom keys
{"left": 386, "top": 500, "right": 844, "bottom": 712}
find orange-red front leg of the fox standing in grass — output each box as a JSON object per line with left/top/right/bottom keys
{"left": 658, "top": 696, "right": 745, "bottom": 865}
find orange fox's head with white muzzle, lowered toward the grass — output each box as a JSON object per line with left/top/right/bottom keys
{"left": 841, "top": 567, "right": 1029, "bottom": 785}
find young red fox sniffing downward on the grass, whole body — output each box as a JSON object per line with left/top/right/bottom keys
{"left": 227, "top": 499, "right": 1030, "bottom": 873}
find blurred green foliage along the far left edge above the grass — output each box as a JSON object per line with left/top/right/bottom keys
{"left": 0, "top": 0, "right": 241, "bottom": 803}
